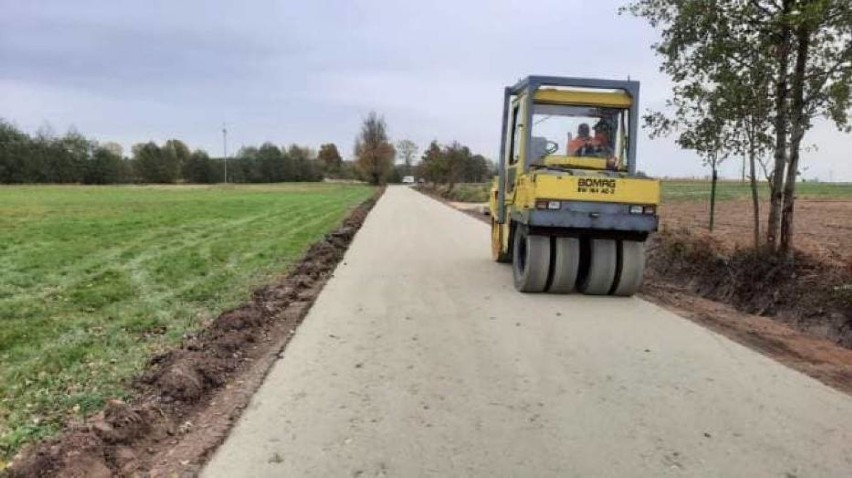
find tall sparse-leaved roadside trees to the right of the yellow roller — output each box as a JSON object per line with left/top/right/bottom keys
{"left": 622, "top": 0, "right": 852, "bottom": 259}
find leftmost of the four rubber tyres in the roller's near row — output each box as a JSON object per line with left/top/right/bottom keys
{"left": 512, "top": 227, "right": 550, "bottom": 292}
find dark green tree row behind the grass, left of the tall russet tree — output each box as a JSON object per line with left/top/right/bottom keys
{"left": 0, "top": 120, "right": 342, "bottom": 184}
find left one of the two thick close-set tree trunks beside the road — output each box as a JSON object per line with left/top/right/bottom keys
{"left": 766, "top": 0, "right": 792, "bottom": 252}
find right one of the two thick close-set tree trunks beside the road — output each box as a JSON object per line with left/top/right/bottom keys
{"left": 779, "top": 24, "right": 811, "bottom": 259}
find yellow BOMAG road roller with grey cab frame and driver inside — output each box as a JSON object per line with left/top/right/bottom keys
{"left": 489, "top": 76, "right": 660, "bottom": 296}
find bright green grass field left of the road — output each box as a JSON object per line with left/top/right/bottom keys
{"left": 0, "top": 184, "right": 373, "bottom": 458}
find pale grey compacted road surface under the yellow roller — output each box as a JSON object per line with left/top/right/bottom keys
{"left": 204, "top": 187, "right": 852, "bottom": 477}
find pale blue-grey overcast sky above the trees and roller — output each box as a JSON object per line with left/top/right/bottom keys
{"left": 0, "top": 0, "right": 852, "bottom": 181}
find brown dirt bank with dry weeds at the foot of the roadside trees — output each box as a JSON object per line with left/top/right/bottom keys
{"left": 648, "top": 228, "right": 852, "bottom": 348}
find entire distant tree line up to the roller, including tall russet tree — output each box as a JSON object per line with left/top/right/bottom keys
{"left": 0, "top": 113, "right": 494, "bottom": 188}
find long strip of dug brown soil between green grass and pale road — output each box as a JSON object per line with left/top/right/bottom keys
{"left": 9, "top": 191, "right": 383, "bottom": 478}
